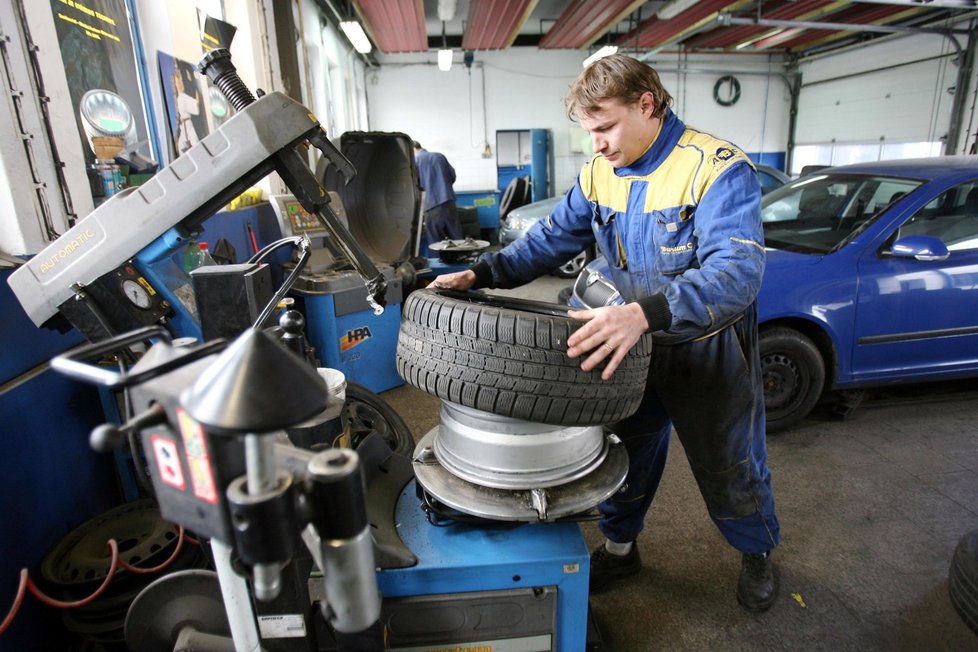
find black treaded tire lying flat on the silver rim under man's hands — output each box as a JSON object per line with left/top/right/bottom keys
{"left": 397, "top": 290, "right": 652, "bottom": 425}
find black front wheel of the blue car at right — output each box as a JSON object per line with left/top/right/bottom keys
{"left": 760, "top": 328, "right": 825, "bottom": 432}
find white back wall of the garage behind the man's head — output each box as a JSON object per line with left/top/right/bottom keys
{"left": 367, "top": 48, "right": 788, "bottom": 193}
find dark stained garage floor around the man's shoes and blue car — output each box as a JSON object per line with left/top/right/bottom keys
{"left": 383, "top": 278, "right": 978, "bottom": 651}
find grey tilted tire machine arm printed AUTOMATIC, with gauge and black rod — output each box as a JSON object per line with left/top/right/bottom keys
{"left": 8, "top": 49, "right": 387, "bottom": 341}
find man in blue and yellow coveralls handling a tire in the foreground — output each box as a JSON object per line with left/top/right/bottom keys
{"left": 432, "top": 55, "right": 780, "bottom": 611}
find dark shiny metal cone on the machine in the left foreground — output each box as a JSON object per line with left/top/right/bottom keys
{"left": 180, "top": 329, "right": 328, "bottom": 435}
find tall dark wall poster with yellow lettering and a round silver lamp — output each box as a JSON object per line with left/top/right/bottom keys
{"left": 51, "top": 0, "right": 152, "bottom": 163}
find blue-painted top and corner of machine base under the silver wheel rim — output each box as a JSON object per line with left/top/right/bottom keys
{"left": 377, "top": 481, "right": 590, "bottom": 652}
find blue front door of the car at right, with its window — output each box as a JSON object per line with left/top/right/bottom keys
{"left": 852, "top": 180, "right": 978, "bottom": 382}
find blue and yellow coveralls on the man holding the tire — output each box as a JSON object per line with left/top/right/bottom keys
{"left": 473, "top": 110, "right": 780, "bottom": 553}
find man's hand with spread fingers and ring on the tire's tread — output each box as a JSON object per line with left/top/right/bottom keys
{"left": 564, "top": 304, "right": 649, "bottom": 380}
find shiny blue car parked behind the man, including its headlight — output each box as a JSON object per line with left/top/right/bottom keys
{"left": 570, "top": 156, "right": 978, "bottom": 432}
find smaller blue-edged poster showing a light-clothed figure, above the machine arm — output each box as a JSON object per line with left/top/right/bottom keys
{"left": 159, "top": 52, "right": 208, "bottom": 158}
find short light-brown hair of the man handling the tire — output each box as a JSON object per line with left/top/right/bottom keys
{"left": 564, "top": 54, "right": 672, "bottom": 120}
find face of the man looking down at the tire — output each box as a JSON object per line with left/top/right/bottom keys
{"left": 577, "top": 93, "right": 659, "bottom": 168}
